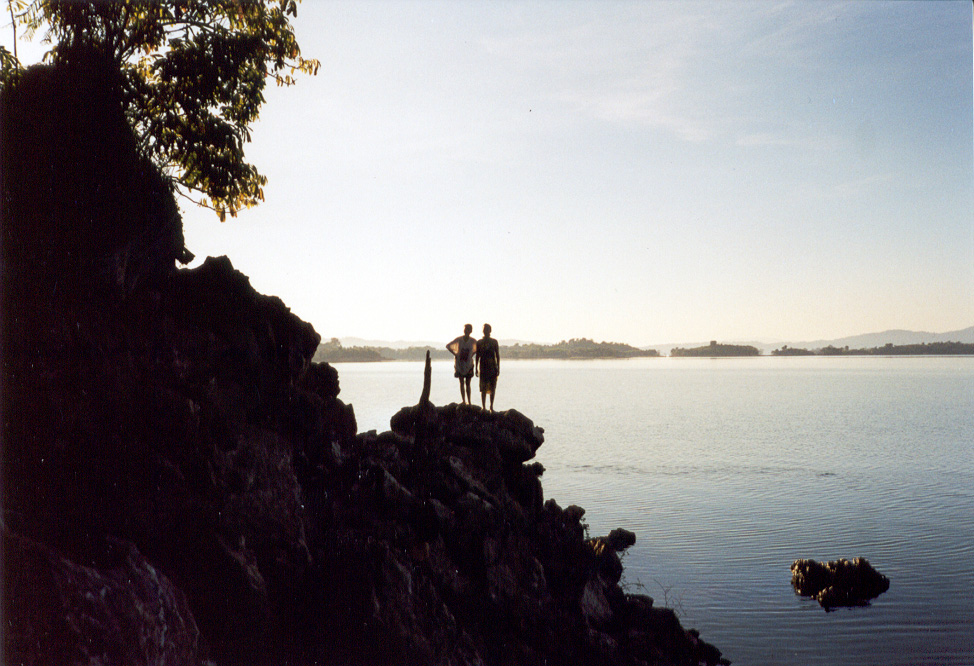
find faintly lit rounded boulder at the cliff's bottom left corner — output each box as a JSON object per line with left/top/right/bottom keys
{"left": 3, "top": 531, "right": 205, "bottom": 666}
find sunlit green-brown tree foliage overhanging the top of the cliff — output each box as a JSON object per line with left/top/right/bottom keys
{"left": 8, "top": 0, "right": 319, "bottom": 220}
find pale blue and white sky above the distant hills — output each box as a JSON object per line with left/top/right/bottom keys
{"left": 0, "top": 0, "right": 974, "bottom": 346}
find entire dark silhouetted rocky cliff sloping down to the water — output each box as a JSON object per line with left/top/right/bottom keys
{"left": 0, "top": 55, "right": 720, "bottom": 666}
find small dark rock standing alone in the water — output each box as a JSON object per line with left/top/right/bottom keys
{"left": 791, "top": 557, "right": 889, "bottom": 611}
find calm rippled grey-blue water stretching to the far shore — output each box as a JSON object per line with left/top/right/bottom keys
{"left": 337, "top": 357, "right": 974, "bottom": 666}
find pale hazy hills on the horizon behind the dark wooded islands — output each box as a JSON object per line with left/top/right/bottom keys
{"left": 339, "top": 326, "right": 974, "bottom": 356}
